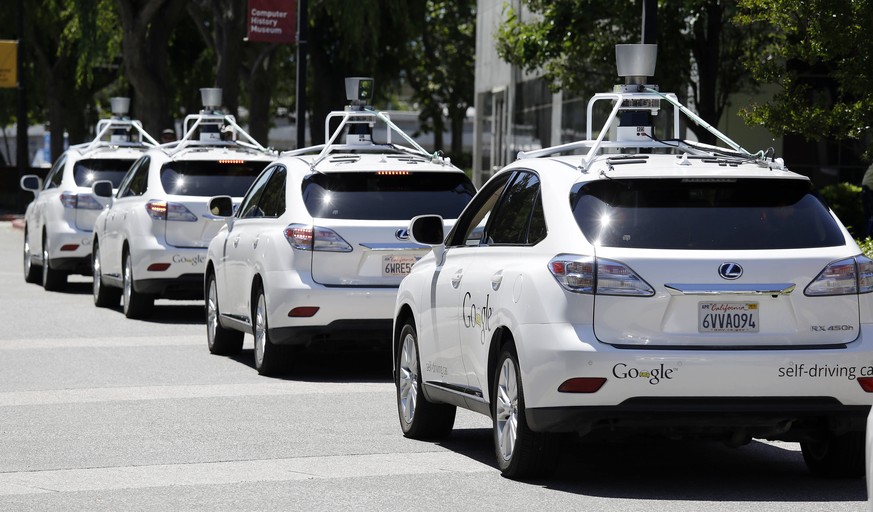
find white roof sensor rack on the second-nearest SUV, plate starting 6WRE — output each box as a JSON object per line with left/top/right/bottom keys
{"left": 282, "top": 77, "right": 451, "bottom": 170}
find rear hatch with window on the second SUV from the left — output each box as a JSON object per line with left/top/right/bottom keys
{"left": 157, "top": 159, "right": 269, "bottom": 248}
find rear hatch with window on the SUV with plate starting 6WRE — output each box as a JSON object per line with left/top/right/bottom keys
{"left": 302, "top": 171, "right": 475, "bottom": 287}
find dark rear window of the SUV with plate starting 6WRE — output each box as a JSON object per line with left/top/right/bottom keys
{"left": 303, "top": 172, "right": 476, "bottom": 220}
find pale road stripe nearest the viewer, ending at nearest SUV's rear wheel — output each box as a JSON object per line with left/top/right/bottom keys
{"left": 0, "top": 451, "right": 496, "bottom": 495}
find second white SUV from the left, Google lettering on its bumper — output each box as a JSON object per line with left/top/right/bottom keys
{"left": 91, "top": 89, "right": 276, "bottom": 318}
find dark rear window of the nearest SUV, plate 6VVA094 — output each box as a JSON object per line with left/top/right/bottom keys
{"left": 570, "top": 179, "right": 845, "bottom": 250}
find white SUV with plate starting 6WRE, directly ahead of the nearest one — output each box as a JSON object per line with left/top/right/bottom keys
{"left": 205, "top": 78, "right": 475, "bottom": 374}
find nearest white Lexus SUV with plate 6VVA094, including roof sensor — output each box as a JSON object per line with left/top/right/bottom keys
{"left": 394, "top": 45, "right": 873, "bottom": 478}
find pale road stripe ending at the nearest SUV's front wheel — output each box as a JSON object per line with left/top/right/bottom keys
{"left": 0, "top": 381, "right": 394, "bottom": 407}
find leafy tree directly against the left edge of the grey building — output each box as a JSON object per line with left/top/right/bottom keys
{"left": 404, "top": 0, "right": 476, "bottom": 162}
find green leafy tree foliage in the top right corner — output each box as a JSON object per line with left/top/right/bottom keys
{"left": 739, "top": 0, "right": 873, "bottom": 159}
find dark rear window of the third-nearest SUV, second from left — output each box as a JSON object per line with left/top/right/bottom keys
{"left": 161, "top": 160, "right": 269, "bottom": 197}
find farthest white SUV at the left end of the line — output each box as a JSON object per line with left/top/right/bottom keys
{"left": 21, "top": 97, "right": 158, "bottom": 290}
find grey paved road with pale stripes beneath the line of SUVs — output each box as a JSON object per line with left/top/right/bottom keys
{"left": 0, "top": 222, "right": 866, "bottom": 512}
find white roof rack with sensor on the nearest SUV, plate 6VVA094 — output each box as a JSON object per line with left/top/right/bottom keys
{"left": 518, "top": 44, "right": 784, "bottom": 171}
